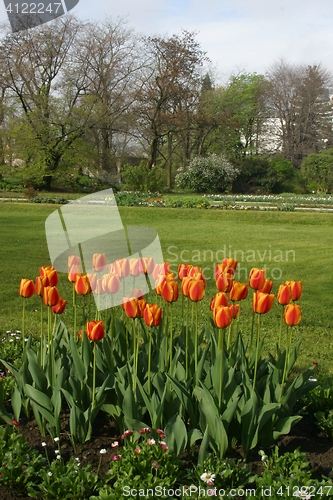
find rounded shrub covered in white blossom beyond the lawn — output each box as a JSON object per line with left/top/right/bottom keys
{"left": 176, "top": 153, "right": 239, "bottom": 193}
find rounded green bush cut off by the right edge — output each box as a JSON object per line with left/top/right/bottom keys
{"left": 300, "top": 149, "right": 333, "bottom": 193}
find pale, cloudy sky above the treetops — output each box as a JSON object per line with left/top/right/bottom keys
{"left": 0, "top": 0, "right": 333, "bottom": 82}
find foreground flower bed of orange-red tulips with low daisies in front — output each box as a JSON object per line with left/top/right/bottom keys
{"left": 0, "top": 254, "right": 332, "bottom": 498}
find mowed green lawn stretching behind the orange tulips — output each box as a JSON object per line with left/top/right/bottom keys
{"left": 0, "top": 203, "right": 333, "bottom": 373}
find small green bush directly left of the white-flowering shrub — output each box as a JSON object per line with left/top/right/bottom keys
{"left": 121, "top": 161, "right": 166, "bottom": 192}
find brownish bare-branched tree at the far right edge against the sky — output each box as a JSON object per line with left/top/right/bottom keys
{"left": 267, "top": 61, "right": 332, "bottom": 166}
